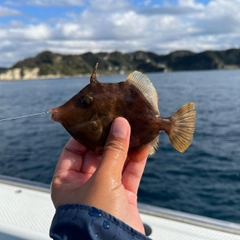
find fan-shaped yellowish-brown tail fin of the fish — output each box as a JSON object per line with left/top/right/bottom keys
{"left": 168, "top": 102, "right": 196, "bottom": 152}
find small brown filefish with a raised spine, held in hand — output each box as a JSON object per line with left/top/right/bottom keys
{"left": 49, "top": 64, "right": 196, "bottom": 155}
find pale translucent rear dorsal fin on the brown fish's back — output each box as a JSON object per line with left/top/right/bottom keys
{"left": 126, "top": 71, "right": 160, "bottom": 114}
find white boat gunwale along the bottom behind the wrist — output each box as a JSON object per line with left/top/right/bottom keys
{"left": 0, "top": 175, "right": 240, "bottom": 240}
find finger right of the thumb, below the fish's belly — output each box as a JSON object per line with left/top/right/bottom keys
{"left": 122, "top": 145, "right": 150, "bottom": 194}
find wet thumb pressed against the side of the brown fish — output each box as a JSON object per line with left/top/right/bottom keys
{"left": 98, "top": 117, "right": 130, "bottom": 181}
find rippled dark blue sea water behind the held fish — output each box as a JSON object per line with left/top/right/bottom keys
{"left": 0, "top": 70, "right": 240, "bottom": 223}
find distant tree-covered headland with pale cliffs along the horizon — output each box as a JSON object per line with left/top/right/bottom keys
{"left": 0, "top": 48, "right": 240, "bottom": 81}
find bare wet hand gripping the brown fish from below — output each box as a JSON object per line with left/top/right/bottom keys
{"left": 51, "top": 118, "right": 150, "bottom": 233}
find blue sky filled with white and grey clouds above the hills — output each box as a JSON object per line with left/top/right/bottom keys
{"left": 0, "top": 0, "right": 240, "bottom": 67}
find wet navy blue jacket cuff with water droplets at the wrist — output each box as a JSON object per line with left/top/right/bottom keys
{"left": 50, "top": 204, "right": 150, "bottom": 240}
